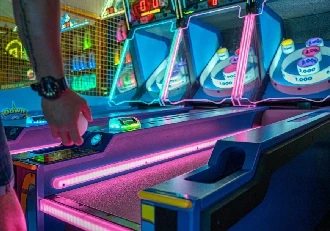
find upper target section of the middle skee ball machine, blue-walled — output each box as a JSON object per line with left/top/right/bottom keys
{"left": 162, "top": 0, "right": 260, "bottom": 105}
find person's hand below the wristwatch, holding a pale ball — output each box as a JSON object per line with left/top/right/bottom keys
{"left": 41, "top": 89, "right": 93, "bottom": 146}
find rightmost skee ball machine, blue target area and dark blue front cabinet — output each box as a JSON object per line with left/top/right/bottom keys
{"left": 140, "top": 0, "right": 330, "bottom": 231}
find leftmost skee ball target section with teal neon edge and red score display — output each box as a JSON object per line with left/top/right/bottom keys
{"left": 110, "top": 0, "right": 190, "bottom": 107}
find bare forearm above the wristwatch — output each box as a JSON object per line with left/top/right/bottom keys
{"left": 13, "top": 0, "right": 64, "bottom": 80}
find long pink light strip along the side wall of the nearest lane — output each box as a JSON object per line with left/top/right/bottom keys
{"left": 52, "top": 128, "right": 256, "bottom": 189}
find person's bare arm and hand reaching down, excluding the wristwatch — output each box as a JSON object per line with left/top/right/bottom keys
{"left": 13, "top": 0, "right": 92, "bottom": 145}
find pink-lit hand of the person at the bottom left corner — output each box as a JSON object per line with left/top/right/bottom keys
{"left": 0, "top": 189, "right": 27, "bottom": 231}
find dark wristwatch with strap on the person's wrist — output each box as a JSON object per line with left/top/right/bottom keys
{"left": 31, "top": 76, "right": 69, "bottom": 99}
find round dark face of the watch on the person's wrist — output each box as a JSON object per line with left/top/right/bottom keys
{"left": 39, "top": 77, "right": 61, "bottom": 99}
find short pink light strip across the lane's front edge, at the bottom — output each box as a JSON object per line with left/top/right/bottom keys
{"left": 40, "top": 199, "right": 130, "bottom": 231}
